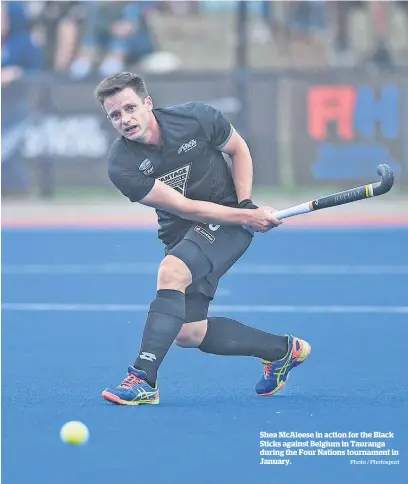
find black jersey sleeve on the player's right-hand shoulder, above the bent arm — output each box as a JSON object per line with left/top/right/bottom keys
{"left": 193, "top": 102, "right": 232, "bottom": 150}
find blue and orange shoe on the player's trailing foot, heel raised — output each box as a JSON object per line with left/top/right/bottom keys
{"left": 255, "top": 335, "right": 311, "bottom": 397}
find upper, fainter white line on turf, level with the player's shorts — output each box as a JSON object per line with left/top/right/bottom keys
{"left": 1, "top": 263, "right": 408, "bottom": 276}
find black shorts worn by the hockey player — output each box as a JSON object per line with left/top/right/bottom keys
{"left": 167, "top": 223, "right": 253, "bottom": 301}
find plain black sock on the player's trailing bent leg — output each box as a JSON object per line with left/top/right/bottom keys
{"left": 199, "top": 318, "right": 288, "bottom": 361}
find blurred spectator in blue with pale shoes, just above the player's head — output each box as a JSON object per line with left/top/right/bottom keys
{"left": 70, "top": 1, "right": 155, "bottom": 79}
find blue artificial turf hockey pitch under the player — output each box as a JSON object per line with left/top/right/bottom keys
{"left": 2, "top": 228, "right": 408, "bottom": 484}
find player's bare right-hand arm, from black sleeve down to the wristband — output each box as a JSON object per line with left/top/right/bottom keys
{"left": 221, "top": 126, "right": 253, "bottom": 202}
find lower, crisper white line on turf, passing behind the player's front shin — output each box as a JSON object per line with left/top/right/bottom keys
{"left": 2, "top": 303, "right": 408, "bottom": 314}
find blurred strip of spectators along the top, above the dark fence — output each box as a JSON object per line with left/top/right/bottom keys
{"left": 2, "top": 0, "right": 408, "bottom": 79}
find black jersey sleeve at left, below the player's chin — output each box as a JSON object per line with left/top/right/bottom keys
{"left": 108, "top": 139, "right": 155, "bottom": 202}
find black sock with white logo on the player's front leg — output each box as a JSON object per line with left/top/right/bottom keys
{"left": 133, "top": 289, "right": 185, "bottom": 386}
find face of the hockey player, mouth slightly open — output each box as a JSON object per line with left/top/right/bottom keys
{"left": 104, "top": 87, "right": 153, "bottom": 141}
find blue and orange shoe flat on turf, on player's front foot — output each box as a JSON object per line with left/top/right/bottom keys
{"left": 102, "top": 366, "right": 160, "bottom": 405}
